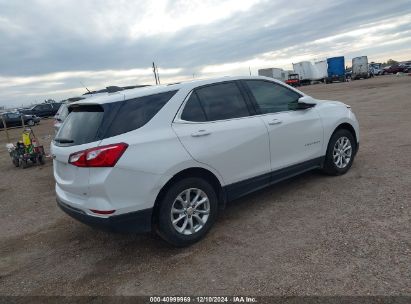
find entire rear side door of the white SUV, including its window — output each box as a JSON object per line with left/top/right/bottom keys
{"left": 173, "top": 81, "right": 270, "bottom": 192}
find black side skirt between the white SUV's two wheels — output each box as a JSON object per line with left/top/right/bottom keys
{"left": 224, "top": 157, "right": 325, "bottom": 201}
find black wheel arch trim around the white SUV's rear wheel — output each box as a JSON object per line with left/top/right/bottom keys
{"left": 152, "top": 167, "right": 227, "bottom": 227}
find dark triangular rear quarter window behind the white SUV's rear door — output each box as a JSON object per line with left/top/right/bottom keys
{"left": 105, "top": 91, "right": 177, "bottom": 137}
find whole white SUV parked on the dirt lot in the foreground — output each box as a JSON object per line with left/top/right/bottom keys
{"left": 52, "top": 77, "right": 359, "bottom": 246}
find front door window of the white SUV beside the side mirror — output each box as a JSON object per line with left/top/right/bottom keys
{"left": 245, "top": 80, "right": 301, "bottom": 114}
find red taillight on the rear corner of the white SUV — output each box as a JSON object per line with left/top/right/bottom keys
{"left": 69, "top": 143, "right": 128, "bottom": 167}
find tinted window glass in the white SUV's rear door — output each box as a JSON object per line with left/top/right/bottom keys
{"left": 195, "top": 82, "right": 249, "bottom": 121}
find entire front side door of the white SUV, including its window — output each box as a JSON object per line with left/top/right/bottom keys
{"left": 243, "top": 80, "right": 323, "bottom": 171}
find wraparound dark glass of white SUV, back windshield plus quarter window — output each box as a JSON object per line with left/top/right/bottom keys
{"left": 54, "top": 91, "right": 177, "bottom": 146}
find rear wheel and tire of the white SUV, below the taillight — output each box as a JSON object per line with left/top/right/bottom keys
{"left": 157, "top": 177, "right": 218, "bottom": 247}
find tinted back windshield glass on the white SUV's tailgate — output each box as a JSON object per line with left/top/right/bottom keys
{"left": 55, "top": 105, "right": 104, "bottom": 146}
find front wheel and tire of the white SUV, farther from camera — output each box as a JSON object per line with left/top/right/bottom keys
{"left": 323, "top": 129, "right": 357, "bottom": 175}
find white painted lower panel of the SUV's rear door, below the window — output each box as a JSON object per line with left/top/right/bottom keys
{"left": 173, "top": 116, "right": 270, "bottom": 184}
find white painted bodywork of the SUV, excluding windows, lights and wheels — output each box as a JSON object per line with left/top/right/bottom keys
{"left": 51, "top": 77, "right": 359, "bottom": 217}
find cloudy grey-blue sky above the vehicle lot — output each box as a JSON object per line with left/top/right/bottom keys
{"left": 0, "top": 0, "right": 411, "bottom": 107}
